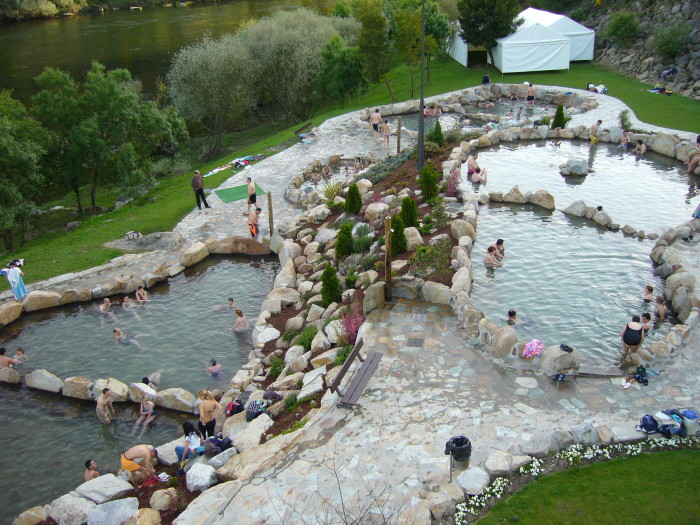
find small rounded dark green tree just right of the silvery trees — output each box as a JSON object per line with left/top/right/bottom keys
{"left": 318, "top": 33, "right": 365, "bottom": 105}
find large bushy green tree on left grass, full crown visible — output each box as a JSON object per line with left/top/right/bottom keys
{"left": 33, "top": 62, "right": 187, "bottom": 212}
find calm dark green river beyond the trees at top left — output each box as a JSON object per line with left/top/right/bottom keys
{"left": 0, "top": 0, "right": 329, "bottom": 104}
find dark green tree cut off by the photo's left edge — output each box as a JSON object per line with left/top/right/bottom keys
{"left": 0, "top": 90, "right": 49, "bottom": 250}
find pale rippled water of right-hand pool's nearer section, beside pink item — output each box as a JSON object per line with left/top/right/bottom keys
{"left": 472, "top": 205, "right": 669, "bottom": 366}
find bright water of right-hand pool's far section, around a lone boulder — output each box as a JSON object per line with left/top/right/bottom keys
{"left": 463, "top": 141, "right": 700, "bottom": 233}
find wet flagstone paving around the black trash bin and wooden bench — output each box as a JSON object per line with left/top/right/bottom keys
{"left": 205, "top": 299, "right": 700, "bottom": 525}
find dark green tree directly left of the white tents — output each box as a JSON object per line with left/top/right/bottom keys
{"left": 457, "top": 0, "right": 523, "bottom": 64}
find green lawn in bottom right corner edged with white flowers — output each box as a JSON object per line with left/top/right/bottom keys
{"left": 477, "top": 449, "right": 700, "bottom": 525}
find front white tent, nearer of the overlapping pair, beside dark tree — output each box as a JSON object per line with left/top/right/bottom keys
{"left": 493, "top": 24, "right": 571, "bottom": 73}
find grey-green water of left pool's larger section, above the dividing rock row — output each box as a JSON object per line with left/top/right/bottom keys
{"left": 0, "top": 257, "right": 279, "bottom": 392}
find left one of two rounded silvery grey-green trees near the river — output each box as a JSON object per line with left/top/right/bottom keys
{"left": 167, "top": 35, "right": 258, "bottom": 158}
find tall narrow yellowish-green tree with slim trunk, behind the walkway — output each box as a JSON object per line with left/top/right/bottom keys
{"left": 357, "top": 0, "right": 396, "bottom": 102}
